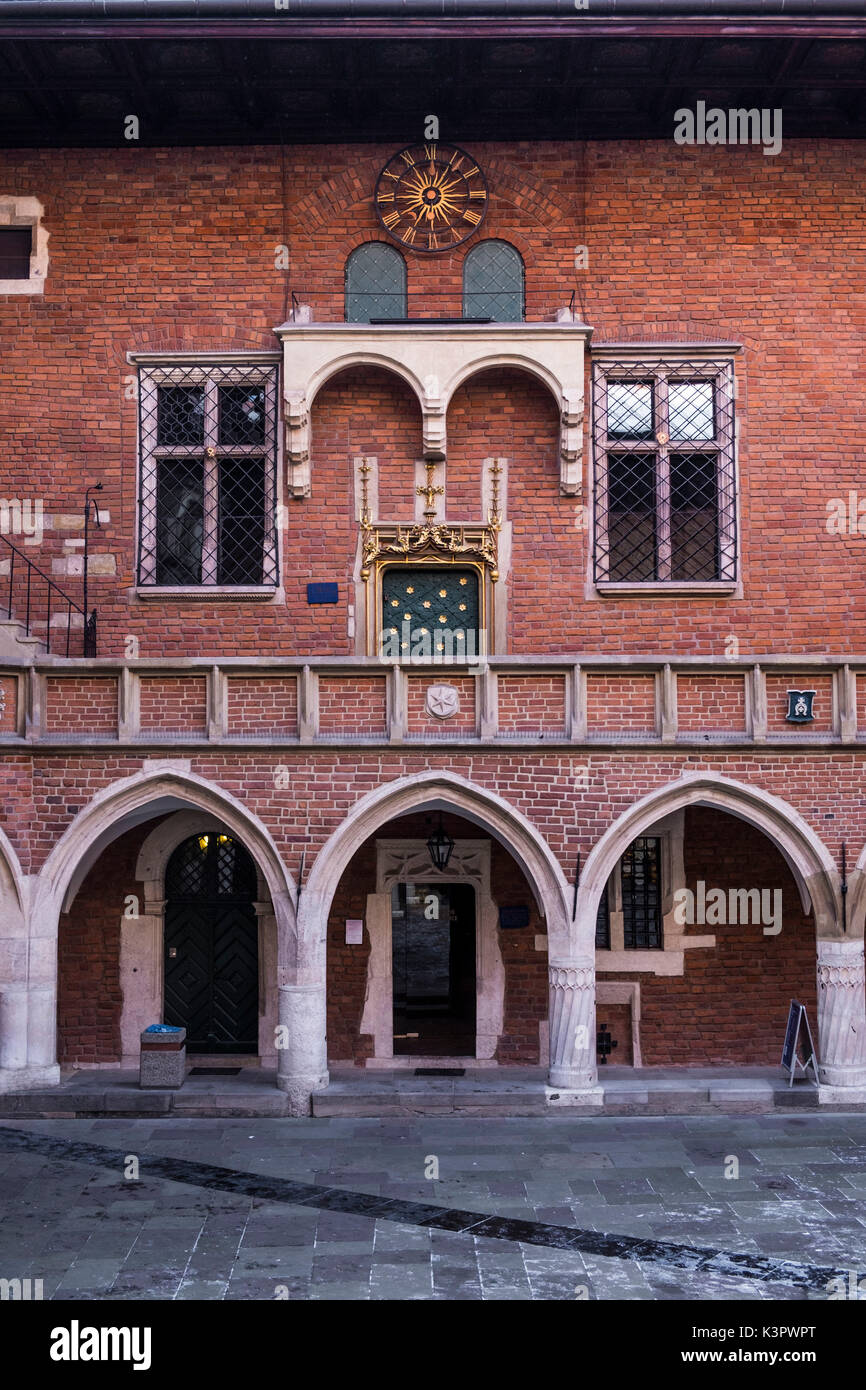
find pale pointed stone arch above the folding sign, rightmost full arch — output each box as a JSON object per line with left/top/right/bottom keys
{"left": 574, "top": 771, "right": 838, "bottom": 951}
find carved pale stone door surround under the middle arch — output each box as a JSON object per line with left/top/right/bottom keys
{"left": 360, "top": 840, "right": 505, "bottom": 1061}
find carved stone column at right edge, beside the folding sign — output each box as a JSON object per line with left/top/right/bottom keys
{"left": 817, "top": 938, "right": 866, "bottom": 1099}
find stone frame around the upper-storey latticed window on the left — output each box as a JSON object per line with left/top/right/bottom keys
{"left": 126, "top": 352, "right": 285, "bottom": 603}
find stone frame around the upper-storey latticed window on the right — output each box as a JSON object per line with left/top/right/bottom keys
{"left": 587, "top": 342, "right": 742, "bottom": 598}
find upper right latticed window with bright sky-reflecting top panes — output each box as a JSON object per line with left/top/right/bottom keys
{"left": 592, "top": 359, "right": 737, "bottom": 584}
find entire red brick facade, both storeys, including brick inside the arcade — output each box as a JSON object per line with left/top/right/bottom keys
{"left": 0, "top": 139, "right": 866, "bottom": 1084}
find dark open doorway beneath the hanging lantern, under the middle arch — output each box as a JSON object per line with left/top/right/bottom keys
{"left": 391, "top": 883, "right": 475, "bottom": 1056}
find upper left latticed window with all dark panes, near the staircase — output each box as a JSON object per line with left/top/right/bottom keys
{"left": 138, "top": 363, "right": 278, "bottom": 588}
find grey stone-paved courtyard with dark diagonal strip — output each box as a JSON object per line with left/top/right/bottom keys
{"left": 0, "top": 1113, "right": 866, "bottom": 1301}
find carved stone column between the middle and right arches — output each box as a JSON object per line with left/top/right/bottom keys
{"left": 549, "top": 956, "right": 602, "bottom": 1105}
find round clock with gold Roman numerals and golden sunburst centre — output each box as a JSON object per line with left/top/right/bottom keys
{"left": 375, "top": 142, "right": 488, "bottom": 253}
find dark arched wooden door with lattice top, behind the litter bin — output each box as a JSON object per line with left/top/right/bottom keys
{"left": 164, "top": 833, "right": 259, "bottom": 1052}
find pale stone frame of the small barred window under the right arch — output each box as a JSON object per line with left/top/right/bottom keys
{"left": 595, "top": 809, "right": 716, "bottom": 976}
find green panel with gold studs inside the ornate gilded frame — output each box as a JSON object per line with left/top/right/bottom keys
{"left": 382, "top": 564, "right": 481, "bottom": 662}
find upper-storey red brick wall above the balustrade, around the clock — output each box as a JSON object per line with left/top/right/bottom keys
{"left": 0, "top": 139, "right": 866, "bottom": 656}
